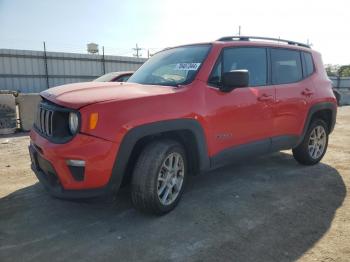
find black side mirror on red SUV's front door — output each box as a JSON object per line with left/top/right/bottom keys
{"left": 220, "top": 70, "right": 249, "bottom": 92}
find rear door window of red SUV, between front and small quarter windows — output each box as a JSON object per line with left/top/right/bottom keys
{"left": 271, "top": 49, "right": 303, "bottom": 84}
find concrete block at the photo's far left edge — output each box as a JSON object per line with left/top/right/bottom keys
{"left": 0, "top": 94, "right": 17, "bottom": 135}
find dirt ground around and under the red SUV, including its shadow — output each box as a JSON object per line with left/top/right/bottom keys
{"left": 0, "top": 107, "right": 350, "bottom": 262}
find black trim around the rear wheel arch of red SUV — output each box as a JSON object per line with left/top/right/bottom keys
{"left": 296, "top": 102, "right": 337, "bottom": 146}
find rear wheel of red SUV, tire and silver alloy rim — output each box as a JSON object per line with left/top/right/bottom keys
{"left": 293, "top": 119, "right": 329, "bottom": 165}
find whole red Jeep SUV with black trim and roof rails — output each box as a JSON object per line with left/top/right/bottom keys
{"left": 29, "top": 36, "right": 337, "bottom": 215}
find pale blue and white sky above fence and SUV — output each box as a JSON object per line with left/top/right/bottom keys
{"left": 0, "top": 0, "right": 350, "bottom": 64}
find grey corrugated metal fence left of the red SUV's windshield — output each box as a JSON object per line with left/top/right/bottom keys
{"left": 0, "top": 49, "right": 146, "bottom": 93}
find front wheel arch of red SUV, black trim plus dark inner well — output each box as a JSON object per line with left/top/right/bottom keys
{"left": 109, "top": 119, "right": 210, "bottom": 190}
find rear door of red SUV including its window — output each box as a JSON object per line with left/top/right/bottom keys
{"left": 270, "top": 48, "right": 314, "bottom": 149}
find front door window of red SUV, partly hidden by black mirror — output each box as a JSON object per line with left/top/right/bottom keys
{"left": 209, "top": 47, "right": 267, "bottom": 86}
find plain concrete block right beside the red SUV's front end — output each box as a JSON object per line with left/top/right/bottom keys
{"left": 16, "top": 93, "right": 41, "bottom": 131}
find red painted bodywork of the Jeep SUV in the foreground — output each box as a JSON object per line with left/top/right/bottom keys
{"left": 31, "top": 41, "right": 336, "bottom": 189}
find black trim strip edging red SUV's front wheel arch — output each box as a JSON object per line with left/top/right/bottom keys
{"left": 108, "top": 118, "right": 210, "bottom": 191}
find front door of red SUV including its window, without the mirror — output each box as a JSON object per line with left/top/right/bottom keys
{"left": 206, "top": 47, "right": 275, "bottom": 159}
